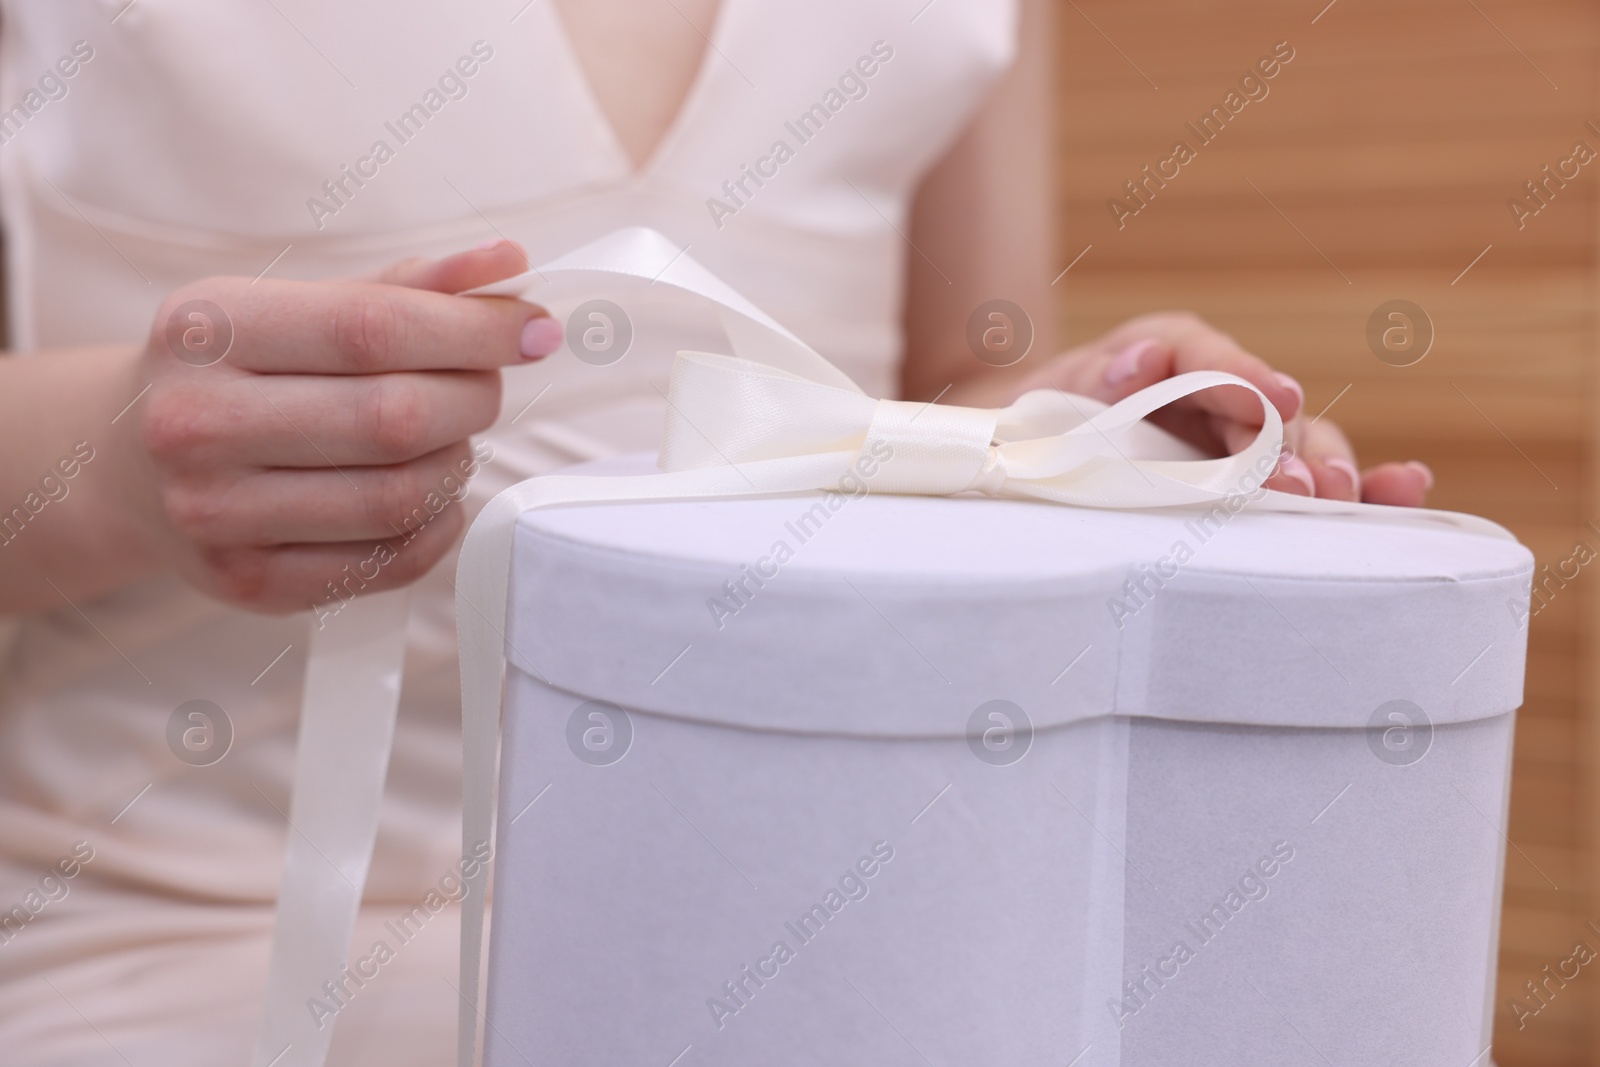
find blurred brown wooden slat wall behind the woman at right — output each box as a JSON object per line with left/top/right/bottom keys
{"left": 1056, "top": 0, "right": 1600, "bottom": 1067}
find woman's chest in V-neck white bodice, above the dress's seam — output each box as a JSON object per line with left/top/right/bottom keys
{"left": 0, "top": 0, "right": 1014, "bottom": 245}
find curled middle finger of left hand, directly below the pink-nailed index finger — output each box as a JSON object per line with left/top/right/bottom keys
{"left": 142, "top": 371, "right": 501, "bottom": 470}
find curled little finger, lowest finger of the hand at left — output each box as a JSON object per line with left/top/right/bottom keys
{"left": 202, "top": 507, "right": 466, "bottom": 621}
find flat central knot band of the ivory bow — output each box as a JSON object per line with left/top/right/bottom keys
{"left": 861, "top": 400, "right": 998, "bottom": 496}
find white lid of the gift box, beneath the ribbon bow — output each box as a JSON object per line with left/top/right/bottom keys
{"left": 506, "top": 458, "right": 1533, "bottom": 736}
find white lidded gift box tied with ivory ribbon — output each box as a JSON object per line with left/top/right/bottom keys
{"left": 483, "top": 461, "right": 1533, "bottom": 1067}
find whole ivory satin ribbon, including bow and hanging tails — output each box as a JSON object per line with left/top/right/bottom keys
{"left": 251, "top": 229, "right": 1510, "bottom": 1067}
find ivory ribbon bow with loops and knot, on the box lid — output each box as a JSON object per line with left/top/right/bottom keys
{"left": 659, "top": 352, "right": 1283, "bottom": 507}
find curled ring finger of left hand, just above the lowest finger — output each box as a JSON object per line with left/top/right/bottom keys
{"left": 163, "top": 443, "right": 477, "bottom": 547}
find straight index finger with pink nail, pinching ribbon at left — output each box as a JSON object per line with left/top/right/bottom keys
{"left": 163, "top": 278, "right": 562, "bottom": 374}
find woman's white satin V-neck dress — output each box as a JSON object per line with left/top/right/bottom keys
{"left": 0, "top": 0, "right": 1016, "bottom": 1067}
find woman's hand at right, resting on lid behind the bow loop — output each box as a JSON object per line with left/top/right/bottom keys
{"left": 1016, "top": 312, "right": 1434, "bottom": 507}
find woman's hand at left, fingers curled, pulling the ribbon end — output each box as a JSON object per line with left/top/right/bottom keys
{"left": 124, "top": 242, "right": 562, "bottom": 613}
